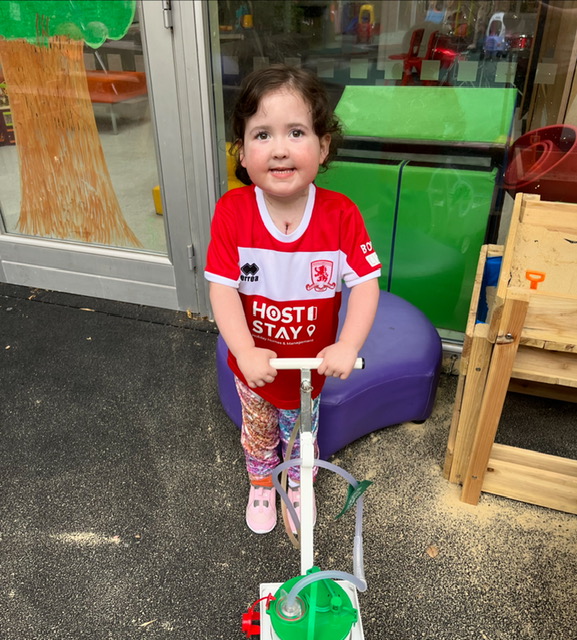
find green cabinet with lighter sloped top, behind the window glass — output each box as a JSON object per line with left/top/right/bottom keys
{"left": 316, "top": 86, "right": 516, "bottom": 333}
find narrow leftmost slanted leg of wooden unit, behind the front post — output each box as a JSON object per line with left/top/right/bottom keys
{"left": 449, "top": 324, "right": 493, "bottom": 484}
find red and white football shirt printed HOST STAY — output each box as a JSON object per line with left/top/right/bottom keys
{"left": 205, "top": 185, "right": 381, "bottom": 409}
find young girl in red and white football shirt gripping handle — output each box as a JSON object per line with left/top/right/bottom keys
{"left": 205, "top": 65, "right": 381, "bottom": 533}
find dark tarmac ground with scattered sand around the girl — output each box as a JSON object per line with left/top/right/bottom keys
{"left": 0, "top": 283, "right": 577, "bottom": 640}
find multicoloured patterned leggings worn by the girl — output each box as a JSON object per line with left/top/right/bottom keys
{"left": 235, "top": 376, "right": 320, "bottom": 486}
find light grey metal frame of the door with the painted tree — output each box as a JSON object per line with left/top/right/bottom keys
{"left": 0, "top": 0, "right": 216, "bottom": 316}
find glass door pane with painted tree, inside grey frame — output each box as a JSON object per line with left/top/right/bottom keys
{"left": 0, "top": 0, "right": 166, "bottom": 253}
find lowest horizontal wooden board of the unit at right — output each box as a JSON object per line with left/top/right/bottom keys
{"left": 483, "top": 444, "right": 577, "bottom": 514}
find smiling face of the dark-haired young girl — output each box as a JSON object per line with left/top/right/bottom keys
{"left": 240, "top": 89, "right": 331, "bottom": 205}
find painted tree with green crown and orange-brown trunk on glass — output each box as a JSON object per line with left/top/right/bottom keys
{"left": 0, "top": 0, "right": 141, "bottom": 246}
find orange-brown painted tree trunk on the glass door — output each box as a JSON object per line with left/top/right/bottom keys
{"left": 0, "top": 36, "right": 141, "bottom": 246}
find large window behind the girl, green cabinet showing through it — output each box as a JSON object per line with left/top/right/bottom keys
{"left": 208, "top": 0, "right": 577, "bottom": 337}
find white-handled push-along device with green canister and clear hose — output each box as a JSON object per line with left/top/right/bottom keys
{"left": 242, "top": 358, "right": 371, "bottom": 640}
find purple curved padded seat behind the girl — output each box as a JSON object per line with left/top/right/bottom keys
{"left": 216, "top": 287, "right": 442, "bottom": 460}
